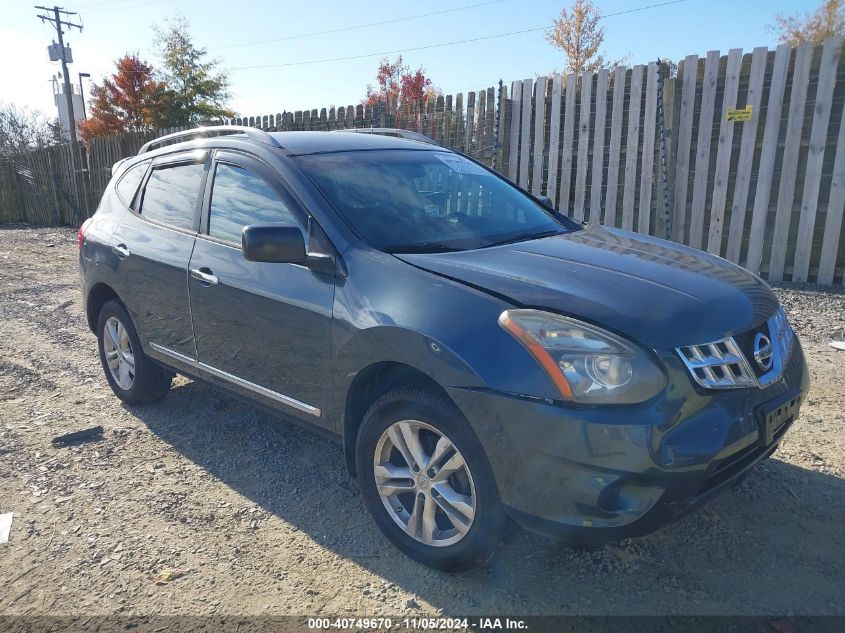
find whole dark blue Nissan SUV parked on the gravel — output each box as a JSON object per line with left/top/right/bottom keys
{"left": 79, "top": 127, "right": 808, "bottom": 569}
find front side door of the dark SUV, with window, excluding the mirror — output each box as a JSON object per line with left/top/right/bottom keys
{"left": 189, "top": 150, "right": 334, "bottom": 424}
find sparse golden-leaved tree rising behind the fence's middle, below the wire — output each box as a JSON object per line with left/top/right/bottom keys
{"left": 546, "top": 0, "right": 612, "bottom": 74}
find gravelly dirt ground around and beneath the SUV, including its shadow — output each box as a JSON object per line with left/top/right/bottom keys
{"left": 0, "top": 228, "right": 845, "bottom": 616}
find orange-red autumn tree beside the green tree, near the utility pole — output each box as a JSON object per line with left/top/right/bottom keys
{"left": 79, "top": 54, "right": 169, "bottom": 141}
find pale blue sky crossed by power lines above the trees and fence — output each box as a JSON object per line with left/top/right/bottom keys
{"left": 0, "top": 0, "right": 819, "bottom": 116}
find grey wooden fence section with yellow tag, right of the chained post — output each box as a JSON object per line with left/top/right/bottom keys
{"left": 669, "top": 37, "right": 845, "bottom": 284}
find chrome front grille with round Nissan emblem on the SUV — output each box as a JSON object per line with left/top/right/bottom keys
{"left": 677, "top": 308, "right": 795, "bottom": 389}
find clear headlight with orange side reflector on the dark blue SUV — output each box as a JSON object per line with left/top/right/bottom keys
{"left": 499, "top": 310, "right": 666, "bottom": 404}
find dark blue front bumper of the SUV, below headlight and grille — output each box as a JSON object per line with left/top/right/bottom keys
{"left": 448, "top": 340, "right": 809, "bottom": 543}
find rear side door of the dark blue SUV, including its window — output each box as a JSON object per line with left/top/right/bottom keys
{"left": 111, "top": 150, "right": 209, "bottom": 362}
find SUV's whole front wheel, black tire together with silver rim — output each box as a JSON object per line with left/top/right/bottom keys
{"left": 356, "top": 388, "right": 509, "bottom": 571}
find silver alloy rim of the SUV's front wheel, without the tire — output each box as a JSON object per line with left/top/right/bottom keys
{"left": 373, "top": 420, "right": 476, "bottom": 547}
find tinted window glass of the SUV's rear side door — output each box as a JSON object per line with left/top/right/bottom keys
{"left": 141, "top": 163, "right": 203, "bottom": 230}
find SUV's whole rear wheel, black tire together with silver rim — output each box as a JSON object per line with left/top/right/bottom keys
{"left": 97, "top": 301, "right": 174, "bottom": 405}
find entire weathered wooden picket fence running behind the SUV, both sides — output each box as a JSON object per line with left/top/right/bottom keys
{"left": 0, "top": 38, "right": 845, "bottom": 284}
